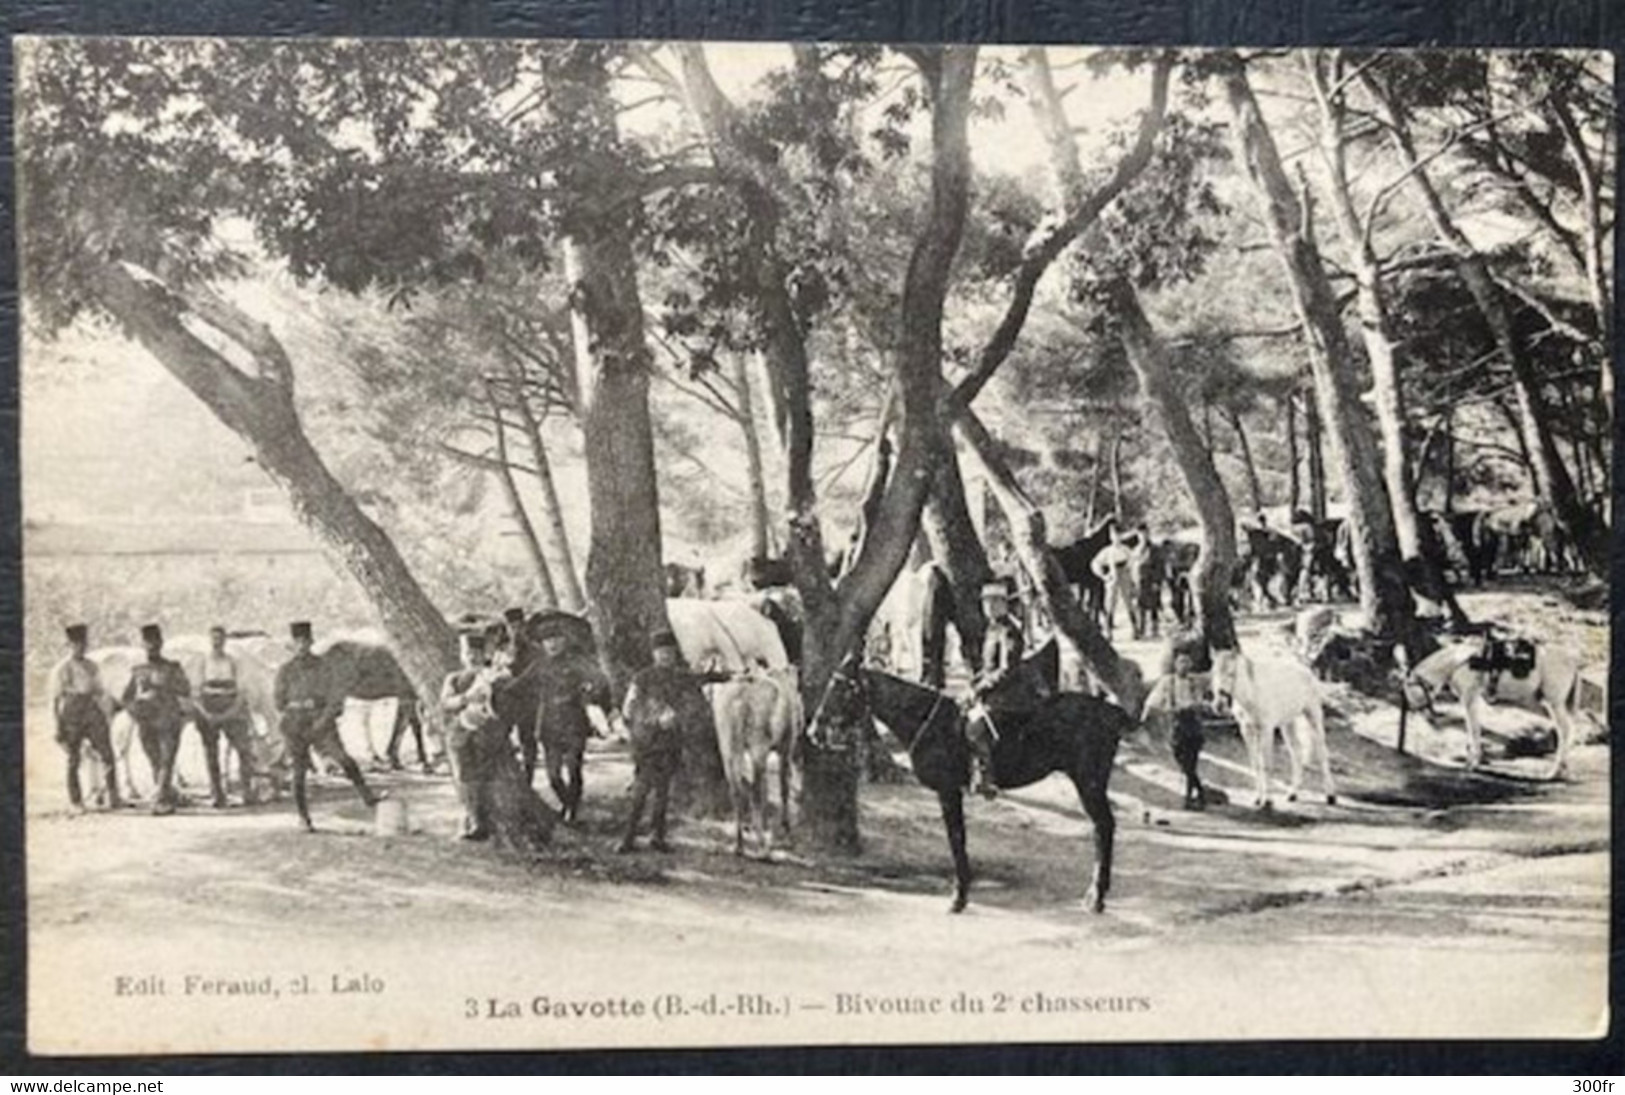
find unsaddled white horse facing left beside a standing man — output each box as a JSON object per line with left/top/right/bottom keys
{"left": 1209, "top": 650, "right": 1337, "bottom": 809}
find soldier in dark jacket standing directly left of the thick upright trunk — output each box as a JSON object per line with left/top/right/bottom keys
{"left": 527, "top": 617, "right": 611, "bottom": 820}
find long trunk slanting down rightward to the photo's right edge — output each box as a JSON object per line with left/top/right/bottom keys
{"left": 1365, "top": 76, "right": 1612, "bottom": 578}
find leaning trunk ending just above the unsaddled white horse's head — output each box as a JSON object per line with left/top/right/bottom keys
{"left": 1112, "top": 281, "right": 1235, "bottom": 650}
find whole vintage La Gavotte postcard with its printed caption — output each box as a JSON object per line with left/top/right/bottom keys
{"left": 15, "top": 37, "right": 1617, "bottom": 1054}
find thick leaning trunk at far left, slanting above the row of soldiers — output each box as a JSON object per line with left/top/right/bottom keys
{"left": 89, "top": 262, "right": 551, "bottom": 851}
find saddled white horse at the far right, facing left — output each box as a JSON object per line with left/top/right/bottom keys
{"left": 1406, "top": 642, "right": 1580, "bottom": 780}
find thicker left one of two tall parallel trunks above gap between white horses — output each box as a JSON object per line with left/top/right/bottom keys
{"left": 1222, "top": 55, "right": 1422, "bottom": 656}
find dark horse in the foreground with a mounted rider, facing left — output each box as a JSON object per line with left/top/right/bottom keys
{"left": 827, "top": 661, "right": 1134, "bottom": 913}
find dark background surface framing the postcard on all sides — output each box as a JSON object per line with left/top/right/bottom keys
{"left": 0, "top": 0, "right": 1625, "bottom": 1072}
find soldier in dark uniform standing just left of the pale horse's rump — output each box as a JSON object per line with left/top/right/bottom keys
{"left": 618, "top": 629, "right": 707, "bottom": 853}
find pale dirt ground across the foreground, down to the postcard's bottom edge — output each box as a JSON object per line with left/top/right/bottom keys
{"left": 28, "top": 597, "right": 1609, "bottom": 1051}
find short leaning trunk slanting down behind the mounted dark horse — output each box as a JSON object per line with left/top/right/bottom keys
{"left": 954, "top": 409, "right": 1146, "bottom": 715}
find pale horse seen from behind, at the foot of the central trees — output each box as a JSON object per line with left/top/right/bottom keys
{"left": 710, "top": 659, "right": 803, "bottom": 856}
